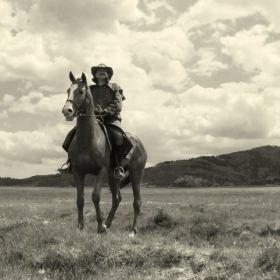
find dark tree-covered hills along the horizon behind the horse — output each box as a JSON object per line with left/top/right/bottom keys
{"left": 0, "top": 146, "right": 280, "bottom": 187}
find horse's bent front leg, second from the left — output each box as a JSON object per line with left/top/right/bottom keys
{"left": 92, "top": 169, "right": 107, "bottom": 233}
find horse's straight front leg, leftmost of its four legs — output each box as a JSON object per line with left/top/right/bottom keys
{"left": 73, "top": 169, "right": 85, "bottom": 230}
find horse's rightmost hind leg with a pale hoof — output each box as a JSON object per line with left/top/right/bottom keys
{"left": 129, "top": 170, "right": 143, "bottom": 237}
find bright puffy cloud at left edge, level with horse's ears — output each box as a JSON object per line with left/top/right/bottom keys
{"left": 0, "top": 27, "right": 74, "bottom": 88}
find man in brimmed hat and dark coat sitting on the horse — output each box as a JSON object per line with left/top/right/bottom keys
{"left": 58, "top": 63, "right": 132, "bottom": 179}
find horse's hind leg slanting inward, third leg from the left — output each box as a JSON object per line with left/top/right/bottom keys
{"left": 105, "top": 169, "right": 122, "bottom": 228}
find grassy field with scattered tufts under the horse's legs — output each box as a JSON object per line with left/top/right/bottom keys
{"left": 0, "top": 187, "right": 280, "bottom": 280}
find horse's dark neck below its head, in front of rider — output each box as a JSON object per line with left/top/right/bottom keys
{"left": 77, "top": 89, "right": 101, "bottom": 148}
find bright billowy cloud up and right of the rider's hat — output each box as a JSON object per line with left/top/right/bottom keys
{"left": 130, "top": 27, "right": 194, "bottom": 91}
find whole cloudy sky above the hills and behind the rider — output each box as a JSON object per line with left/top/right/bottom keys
{"left": 0, "top": 0, "right": 280, "bottom": 178}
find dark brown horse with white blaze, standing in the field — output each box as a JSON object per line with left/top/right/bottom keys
{"left": 62, "top": 72, "right": 147, "bottom": 236}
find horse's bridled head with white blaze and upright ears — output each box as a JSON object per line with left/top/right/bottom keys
{"left": 62, "top": 72, "right": 89, "bottom": 121}
